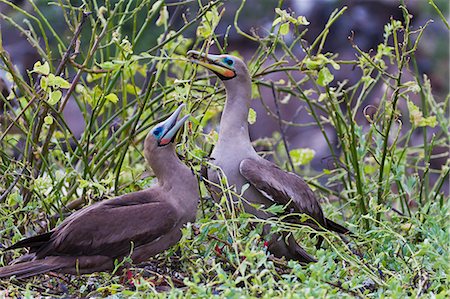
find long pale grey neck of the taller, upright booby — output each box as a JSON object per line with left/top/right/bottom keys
{"left": 219, "top": 81, "right": 251, "bottom": 144}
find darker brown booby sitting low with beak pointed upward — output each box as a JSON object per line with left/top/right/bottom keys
{"left": 0, "top": 105, "right": 199, "bottom": 278}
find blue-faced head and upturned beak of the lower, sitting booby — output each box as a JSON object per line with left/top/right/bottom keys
{"left": 145, "top": 104, "right": 190, "bottom": 159}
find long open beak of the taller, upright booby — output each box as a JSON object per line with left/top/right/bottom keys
{"left": 187, "top": 50, "right": 236, "bottom": 80}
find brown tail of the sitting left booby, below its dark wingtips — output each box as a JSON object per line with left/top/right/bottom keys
{"left": 0, "top": 257, "right": 64, "bottom": 279}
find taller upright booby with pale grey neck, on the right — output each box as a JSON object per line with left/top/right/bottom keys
{"left": 188, "top": 51, "right": 349, "bottom": 263}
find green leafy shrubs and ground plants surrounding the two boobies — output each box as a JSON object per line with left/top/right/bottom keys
{"left": 0, "top": 0, "right": 450, "bottom": 298}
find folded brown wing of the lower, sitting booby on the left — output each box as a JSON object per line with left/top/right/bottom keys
{"left": 36, "top": 189, "right": 178, "bottom": 258}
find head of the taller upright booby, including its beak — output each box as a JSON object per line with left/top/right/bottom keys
{"left": 187, "top": 50, "right": 250, "bottom": 82}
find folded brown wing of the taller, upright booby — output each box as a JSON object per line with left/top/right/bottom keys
{"left": 239, "top": 158, "right": 325, "bottom": 226}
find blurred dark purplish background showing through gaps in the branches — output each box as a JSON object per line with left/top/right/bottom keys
{"left": 0, "top": 0, "right": 449, "bottom": 170}
